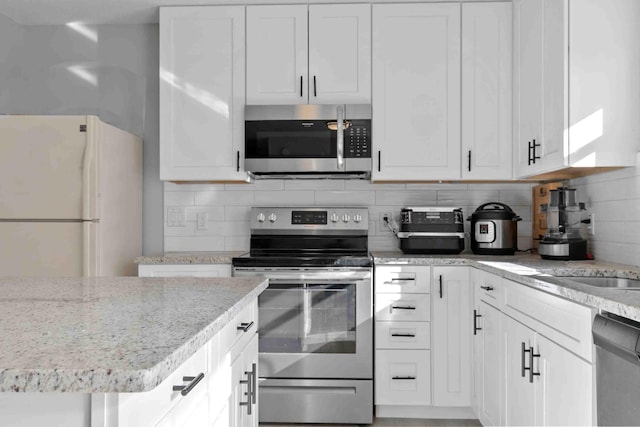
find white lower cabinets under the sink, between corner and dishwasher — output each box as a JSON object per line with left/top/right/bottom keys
{"left": 472, "top": 271, "right": 595, "bottom": 426}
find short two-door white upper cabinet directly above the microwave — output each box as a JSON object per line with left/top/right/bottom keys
{"left": 247, "top": 4, "right": 371, "bottom": 104}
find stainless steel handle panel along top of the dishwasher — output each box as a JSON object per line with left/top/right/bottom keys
{"left": 591, "top": 313, "right": 640, "bottom": 366}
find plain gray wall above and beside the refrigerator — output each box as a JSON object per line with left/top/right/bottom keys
{"left": 0, "top": 15, "right": 163, "bottom": 254}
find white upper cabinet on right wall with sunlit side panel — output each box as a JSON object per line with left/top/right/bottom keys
{"left": 513, "top": 0, "right": 640, "bottom": 179}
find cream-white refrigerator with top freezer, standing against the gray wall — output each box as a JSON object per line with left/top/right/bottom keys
{"left": 0, "top": 116, "right": 142, "bottom": 277}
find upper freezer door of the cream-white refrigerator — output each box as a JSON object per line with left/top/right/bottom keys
{"left": 0, "top": 116, "right": 96, "bottom": 220}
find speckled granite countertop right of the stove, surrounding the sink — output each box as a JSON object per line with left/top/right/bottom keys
{"left": 372, "top": 252, "right": 640, "bottom": 321}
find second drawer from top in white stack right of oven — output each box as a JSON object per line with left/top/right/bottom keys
{"left": 376, "top": 294, "right": 431, "bottom": 322}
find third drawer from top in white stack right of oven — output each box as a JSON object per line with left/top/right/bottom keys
{"left": 376, "top": 322, "right": 431, "bottom": 349}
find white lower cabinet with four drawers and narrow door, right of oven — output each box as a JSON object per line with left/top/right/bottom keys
{"left": 375, "top": 265, "right": 472, "bottom": 418}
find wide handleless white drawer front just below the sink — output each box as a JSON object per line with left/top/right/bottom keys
{"left": 503, "top": 280, "right": 595, "bottom": 362}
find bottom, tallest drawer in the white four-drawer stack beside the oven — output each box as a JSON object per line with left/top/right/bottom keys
{"left": 375, "top": 350, "right": 431, "bottom": 405}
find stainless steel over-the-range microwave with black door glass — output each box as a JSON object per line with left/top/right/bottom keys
{"left": 244, "top": 104, "right": 371, "bottom": 178}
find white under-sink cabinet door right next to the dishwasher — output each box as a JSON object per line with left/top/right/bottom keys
{"left": 534, "top": 335, "right": 595, "bottom": 426}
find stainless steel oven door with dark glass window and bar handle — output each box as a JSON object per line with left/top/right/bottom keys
{"left": 234, "top": 268, "right": 373, "bottom": 379}
